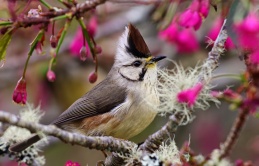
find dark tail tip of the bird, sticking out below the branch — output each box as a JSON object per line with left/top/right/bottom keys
{"left": 9, "top": 134, "right": 41, "bottom": 152}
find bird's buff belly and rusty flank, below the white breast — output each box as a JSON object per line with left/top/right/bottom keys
{"left": 79, "top": 102, "right": 157, "bottom": 139}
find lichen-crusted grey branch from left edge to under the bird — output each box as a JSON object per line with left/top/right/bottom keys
{"left": 0, "top": 111, "right": 136, "bottom": 154}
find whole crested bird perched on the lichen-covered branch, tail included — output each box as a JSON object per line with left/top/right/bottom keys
{"left": 10, "top": 24, "right": 165, "bottom": 152}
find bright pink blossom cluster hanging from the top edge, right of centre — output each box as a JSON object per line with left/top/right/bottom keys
{"left": 179, "top": 0, "right": 210, "bottom": 30}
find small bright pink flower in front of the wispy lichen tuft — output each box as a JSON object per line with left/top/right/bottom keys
{"left": 177, "top": 83, "right": 203, "bottom": 107}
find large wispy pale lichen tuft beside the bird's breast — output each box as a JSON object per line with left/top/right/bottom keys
{"left": 157, "top": 61, "right": 220, "bottom": 125}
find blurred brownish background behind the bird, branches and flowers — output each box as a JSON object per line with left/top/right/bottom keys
{"left": 0, "top": 0, "right": 259, "bottom": 166}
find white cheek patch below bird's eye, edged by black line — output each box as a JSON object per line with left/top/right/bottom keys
{"left": 119, "top": 66, "right": 142, "bottom": 81}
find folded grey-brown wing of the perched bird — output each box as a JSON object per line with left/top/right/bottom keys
{"left": 52, "top": 78, "right": 126, "bottom": 126}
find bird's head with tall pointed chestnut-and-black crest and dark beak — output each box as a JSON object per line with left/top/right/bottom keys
{"left": 114, "top": 24, "right": 165, "bottom": 82}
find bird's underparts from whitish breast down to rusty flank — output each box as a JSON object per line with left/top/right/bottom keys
{"left": 76, "top": 84, "right": 159, "bottom": 139}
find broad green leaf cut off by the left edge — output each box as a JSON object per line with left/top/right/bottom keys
{"left": 0, "top": 30, "right": 12, "bottom": 61}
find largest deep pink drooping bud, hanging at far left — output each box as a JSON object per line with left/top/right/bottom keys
{"left": 13, "top": 77, "right": 27, "bottom": 104}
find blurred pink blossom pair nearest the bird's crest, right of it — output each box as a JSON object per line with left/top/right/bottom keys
{"left": 158, "top": 22, "right": 199, "bottom": 53}
